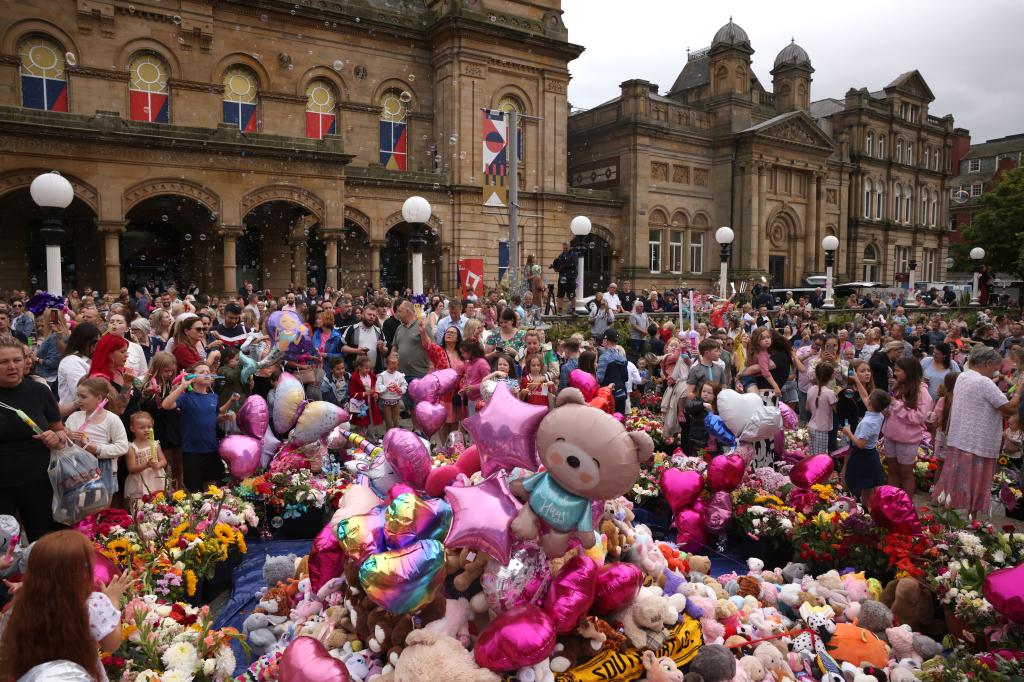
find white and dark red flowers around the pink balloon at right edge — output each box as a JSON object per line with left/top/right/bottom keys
{"left": 931, "top": 521, "right": 1024, "bottom": 630}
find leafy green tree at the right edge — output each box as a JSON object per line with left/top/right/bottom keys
{"left": 953, "top": 167, "right": 1024, "bottom": 279}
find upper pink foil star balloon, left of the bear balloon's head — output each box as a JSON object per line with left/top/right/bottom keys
{"left": 463, "top": 384, "right": 548, "bottom": 476}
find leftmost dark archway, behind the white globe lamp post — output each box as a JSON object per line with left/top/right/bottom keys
{"left": 0, "top": 187, "right": 99, "bottom": 295}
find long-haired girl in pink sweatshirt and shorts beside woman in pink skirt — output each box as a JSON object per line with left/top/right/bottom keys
{"left": 882, "top": 357, "right": 932, "bottom": 498}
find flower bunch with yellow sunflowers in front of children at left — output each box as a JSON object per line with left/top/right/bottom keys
{"left": 77, "top": 485, "right": 258, "bottom": 600}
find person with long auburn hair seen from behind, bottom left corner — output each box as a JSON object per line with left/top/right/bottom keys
{"left": 0, "top": 530, "right": 130, "bottom": 682}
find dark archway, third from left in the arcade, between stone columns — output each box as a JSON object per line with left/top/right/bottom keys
{"left": 236, "top": 200, "right": 317, "bottom": 293}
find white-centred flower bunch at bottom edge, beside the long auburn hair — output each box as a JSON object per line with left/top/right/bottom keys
{"left": 103, "top": 595, "right": 248, "bottom": 682}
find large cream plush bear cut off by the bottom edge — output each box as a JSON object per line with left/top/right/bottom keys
{"left": 371, "top": 630, "right": 502, "bottom": 682}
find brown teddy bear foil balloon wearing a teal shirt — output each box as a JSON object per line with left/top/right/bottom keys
{"left": 511, "top": 387, "right": 654, "bottom": 557}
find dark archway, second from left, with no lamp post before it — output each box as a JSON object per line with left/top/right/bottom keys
{"left": 121, "top": 195, "right": 223, "bottom": 293}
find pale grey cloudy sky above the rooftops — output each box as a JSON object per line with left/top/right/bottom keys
{"left": 562, "top": 0, "right": 1024, "bottom": 141}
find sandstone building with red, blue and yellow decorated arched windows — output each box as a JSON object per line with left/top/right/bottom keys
{"left": 0, "top": 0, "right": 623, "bottom": 292}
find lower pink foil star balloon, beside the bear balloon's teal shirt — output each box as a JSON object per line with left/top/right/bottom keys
{"left": 444, "top": 472, "right": 522, "bottom": 564}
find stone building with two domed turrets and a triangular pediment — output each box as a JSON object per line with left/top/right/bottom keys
{"left": 568, "top": 19, "right": 953, "bottom": 287}
